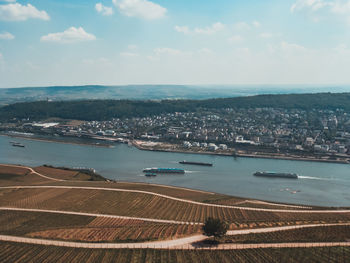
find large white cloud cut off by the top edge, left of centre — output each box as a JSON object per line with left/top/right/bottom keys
{"left": 113, "top": 0, "right": 167, "bottom": 20}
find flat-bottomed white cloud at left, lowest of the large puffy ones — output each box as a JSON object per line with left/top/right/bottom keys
{"left": 40, "top": 27, "right": 96, "bottom": 43}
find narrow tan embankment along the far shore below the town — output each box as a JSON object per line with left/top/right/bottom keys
{"left": 132, "top": 140, "right": 350, "bottom": 164}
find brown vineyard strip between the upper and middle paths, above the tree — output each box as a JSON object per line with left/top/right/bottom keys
{"left": 0, "top": 188, "right": 350, "bottom": 228}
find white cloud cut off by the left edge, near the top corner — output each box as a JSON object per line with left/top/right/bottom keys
{"left": 0, "top": 3, "right": 50, "bottom": 21}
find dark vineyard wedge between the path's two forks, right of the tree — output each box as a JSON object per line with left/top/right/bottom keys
{"left": 223, "top": 226, "right": 350, "bottom": 243}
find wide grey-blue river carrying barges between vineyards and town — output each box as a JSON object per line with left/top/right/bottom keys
{"left": 0, "top": 136, "right": 350, "bottom": 206}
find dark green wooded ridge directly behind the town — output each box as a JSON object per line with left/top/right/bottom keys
{"left": 0, "top": 93, "right": 350, "bottom": 122}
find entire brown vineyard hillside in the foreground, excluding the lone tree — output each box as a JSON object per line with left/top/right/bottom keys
{"left": 0, "top": 165, "right": 350, "bottom": 263}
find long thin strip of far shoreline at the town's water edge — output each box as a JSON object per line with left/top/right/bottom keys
{"left": 132, "top": 142, "right": 350, "bottom": 164}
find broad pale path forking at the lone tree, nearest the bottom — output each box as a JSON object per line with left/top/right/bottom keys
{"left": 0, "top": 223, "right": 350, "bottom": 250}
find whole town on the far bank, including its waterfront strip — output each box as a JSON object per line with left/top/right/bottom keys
{"left": 0, "top": 105, "right": 350, "bottom": 163}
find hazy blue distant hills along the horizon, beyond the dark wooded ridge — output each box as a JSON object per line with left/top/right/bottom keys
{"left": 0, "top": 85, "right": 350, "bottom": 106}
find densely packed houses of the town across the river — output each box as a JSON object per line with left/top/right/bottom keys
{"left": 0, "top": 108, "right": 350, "bottom": 157}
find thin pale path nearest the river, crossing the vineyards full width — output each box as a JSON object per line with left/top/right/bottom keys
{"left": 0, "top": 185, "right": 350, "bottom": 214}
